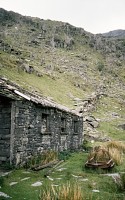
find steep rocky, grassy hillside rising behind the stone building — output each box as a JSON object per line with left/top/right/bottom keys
{"left": 0, "top": 9, "right": 125, "bottom": 139}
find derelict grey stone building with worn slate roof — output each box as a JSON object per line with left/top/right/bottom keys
{"left": 0, "top": 79, "right": 83, "bottom": 165}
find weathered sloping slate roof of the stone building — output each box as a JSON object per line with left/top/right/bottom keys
{"left": 0, "top": 78, "right": 81, "bottom": 116}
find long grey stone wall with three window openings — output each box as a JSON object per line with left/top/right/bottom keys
{"left": 11, "top": 100, "right": 83, "bottom": 164}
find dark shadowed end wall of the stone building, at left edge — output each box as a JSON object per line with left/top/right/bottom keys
{"left": 0, "top": 96, "right": 11, "bottom": 164}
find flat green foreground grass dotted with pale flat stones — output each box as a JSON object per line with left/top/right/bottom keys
{"left": 0, "top": 152, "right": 125, "bottom": 200}
